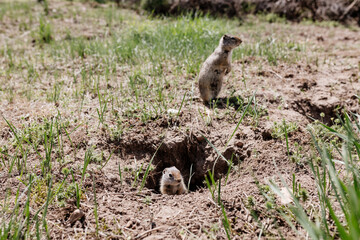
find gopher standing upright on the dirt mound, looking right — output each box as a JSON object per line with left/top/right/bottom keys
{"left": 199, "top": 35, "right": 242, "bottom": 102}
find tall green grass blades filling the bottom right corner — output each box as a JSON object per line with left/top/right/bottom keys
{"left": 272, "top": 113, "right": 360, "bottom": 239}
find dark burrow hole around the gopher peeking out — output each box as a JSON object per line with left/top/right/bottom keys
{"left": 146, "top": 134, "right": 250, "bottom": 191}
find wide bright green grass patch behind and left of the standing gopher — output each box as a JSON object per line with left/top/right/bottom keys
{"left": 52, "top": 13, "right": 235, "bottom": 74}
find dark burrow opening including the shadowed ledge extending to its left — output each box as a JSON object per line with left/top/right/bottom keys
{"left": 114, "top": 133, "right": 250, "bottom": 192}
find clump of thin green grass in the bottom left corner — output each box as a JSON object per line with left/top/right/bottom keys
{"left": 0, "top": 174, "right": 67, "bottom": 239}
